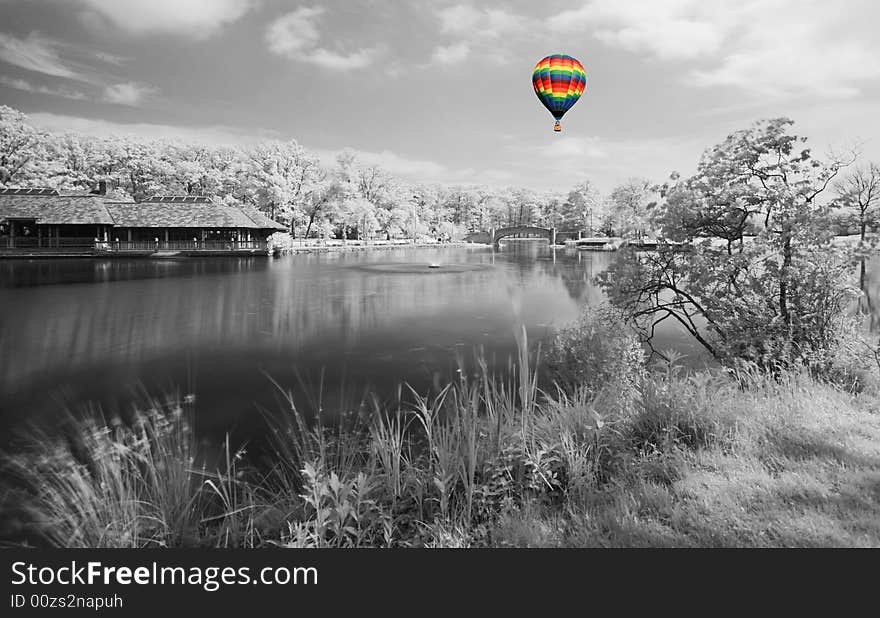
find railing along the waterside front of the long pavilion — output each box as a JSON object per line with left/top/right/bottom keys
{"left": 0, "top": 237, "right": 269, "bottom": 253}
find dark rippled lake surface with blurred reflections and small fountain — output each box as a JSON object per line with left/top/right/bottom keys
{"left": 0, "top": 242, "right": 696, "bottom": 435}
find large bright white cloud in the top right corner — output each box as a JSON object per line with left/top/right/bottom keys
{"left": 549, "top": 0, "right": 880, "bottom": 98}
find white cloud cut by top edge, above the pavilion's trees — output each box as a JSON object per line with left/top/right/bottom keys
{"left": 79, "top": 0, "right": 254, "bottom": 39}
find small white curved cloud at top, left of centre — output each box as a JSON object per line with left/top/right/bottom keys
{"left": 266, "top": 6, "right": 381, "bottom": 71}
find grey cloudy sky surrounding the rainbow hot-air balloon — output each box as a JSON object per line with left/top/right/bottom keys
{"left": 0, "top": 0, "right": 880, "bottom": 191}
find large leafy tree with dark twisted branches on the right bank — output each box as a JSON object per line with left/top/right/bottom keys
{"left": 599, "top": 118, "right": 855, "bottom": 368}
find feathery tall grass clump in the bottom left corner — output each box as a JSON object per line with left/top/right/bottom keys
{"left": 5, "top": 402, "right": 200, "bottom": 547}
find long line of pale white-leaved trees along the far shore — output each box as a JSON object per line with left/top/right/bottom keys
{"left": 0, "top": 106, "right": 655, "bottom": 239}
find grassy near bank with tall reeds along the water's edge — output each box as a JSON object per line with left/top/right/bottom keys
{"left": 3, "top": 332, "right": 880, "bottom": 547}
